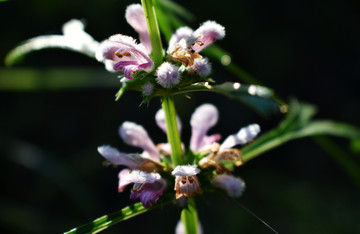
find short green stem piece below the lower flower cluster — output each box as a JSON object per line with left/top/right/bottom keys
{"left": 181, "top": 198, "right": 199, "bottom": 234}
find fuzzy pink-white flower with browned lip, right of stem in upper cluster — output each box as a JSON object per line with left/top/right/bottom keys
{"left": 167, "top": 21, "right": 225, "bottom": 67}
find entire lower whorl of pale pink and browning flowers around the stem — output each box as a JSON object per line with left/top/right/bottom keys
{"left": 98, "top": 104, "right": 260, "bottom": 207}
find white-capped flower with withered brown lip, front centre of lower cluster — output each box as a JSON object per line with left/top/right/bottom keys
{"left": 171, "top": 165, "right": 202, "bottom": 199}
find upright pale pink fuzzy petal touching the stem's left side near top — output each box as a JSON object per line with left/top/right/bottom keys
{"left": 125, "top": 4, "right": 152, "bottom": 54}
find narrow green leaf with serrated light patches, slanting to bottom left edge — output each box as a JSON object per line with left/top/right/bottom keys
{"left": 65, "top": 202, "right": 150, "bottom": 234}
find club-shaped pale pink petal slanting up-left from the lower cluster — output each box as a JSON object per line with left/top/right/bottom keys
{"left": 119, "top": 121, "right": 160, "bottom": 161}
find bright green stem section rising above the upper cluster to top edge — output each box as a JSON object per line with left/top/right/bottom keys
{"left": 141, "top": 0, "right": 164, "bottom": 67}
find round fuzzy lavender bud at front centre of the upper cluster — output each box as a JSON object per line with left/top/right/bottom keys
{"left": 156, "top": 62, "right": 180, "bottom": 88}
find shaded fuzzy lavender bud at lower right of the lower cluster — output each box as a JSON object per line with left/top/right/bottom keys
{"left": 211, "top": 174, "right": 245, "bottom": 198}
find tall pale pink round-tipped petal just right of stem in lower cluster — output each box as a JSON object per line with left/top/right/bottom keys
{"left": 190, "top": 104, "right": 219, "bottom": 151}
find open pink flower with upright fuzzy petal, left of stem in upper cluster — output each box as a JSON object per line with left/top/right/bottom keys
{"left": 96, "top": 4, "right": 154, "bottom": 79}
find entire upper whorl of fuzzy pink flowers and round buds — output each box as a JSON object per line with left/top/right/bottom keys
{"left": 96, "top": 4, "right": 225, "bottom": 93}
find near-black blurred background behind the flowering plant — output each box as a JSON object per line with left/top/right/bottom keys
{"left": 0, "top": 0, "right": 360, "bottom": 233}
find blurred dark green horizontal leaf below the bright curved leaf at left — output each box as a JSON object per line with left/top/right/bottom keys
{"left": 0, "top": 67, "right": 120, "bottom": 91}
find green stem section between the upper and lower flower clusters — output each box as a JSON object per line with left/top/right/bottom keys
{"left": 162, "top": 96, "right": 183, "bottom": 166}
